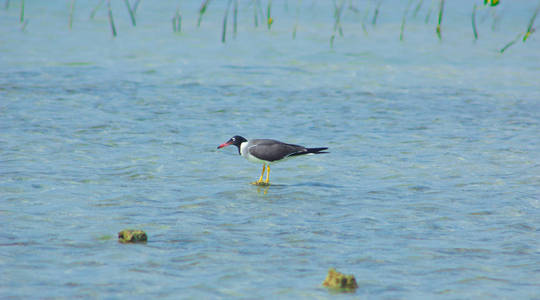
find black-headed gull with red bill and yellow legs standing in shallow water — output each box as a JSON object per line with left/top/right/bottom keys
{"left": 218, "top": 135, "right": 328, "bottom": 185}
